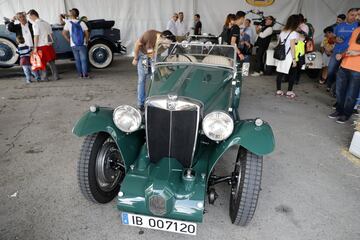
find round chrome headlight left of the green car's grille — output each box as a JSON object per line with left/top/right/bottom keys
{"left": 113, "top": 105, "right": 141, "bottom": 133}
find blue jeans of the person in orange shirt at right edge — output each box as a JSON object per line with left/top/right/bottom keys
{"left": 336, "top": 67, "right": 360, "bottom": 117}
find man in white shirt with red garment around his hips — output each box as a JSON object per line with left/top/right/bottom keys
{"left": 28, "top": 9, "right": 59, "bottom": 81}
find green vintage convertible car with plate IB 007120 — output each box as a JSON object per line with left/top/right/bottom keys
{"left": 73, "top": 43, "right": 275, "bottom": 235}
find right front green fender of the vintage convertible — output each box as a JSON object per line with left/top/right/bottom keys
{"left": 208, "top": 120, "right": 275, "bottom": 176}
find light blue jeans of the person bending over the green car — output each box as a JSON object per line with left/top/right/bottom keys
{"left": 137, "top": 53, "right": 151, "bottom": 106}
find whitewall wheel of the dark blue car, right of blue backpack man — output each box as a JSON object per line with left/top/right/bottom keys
{"left": 88, "top": 40, "right": 114, "bottom": 69}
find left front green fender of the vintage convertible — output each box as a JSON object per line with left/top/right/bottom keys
{"left": 73, "top": 107, "right": 145, "bottom": 169}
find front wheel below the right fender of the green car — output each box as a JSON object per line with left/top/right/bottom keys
{"left": 230, "top": 147, "right": 263, "bottom": 226}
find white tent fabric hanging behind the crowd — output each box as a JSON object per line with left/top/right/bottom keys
{"left": 0, "top": 0, "right": 354, "bottom": 54}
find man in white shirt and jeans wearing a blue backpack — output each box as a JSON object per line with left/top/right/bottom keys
{"left": 62, "top": 8, "right": 89, "bottom": 78}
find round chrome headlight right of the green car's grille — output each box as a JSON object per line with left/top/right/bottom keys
{"left": 202, "top": 112, "right": 234, "bottom": 141}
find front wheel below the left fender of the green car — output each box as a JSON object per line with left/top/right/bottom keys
{"left": 78, "top": 133, "right": 125, "bottom": 203}
